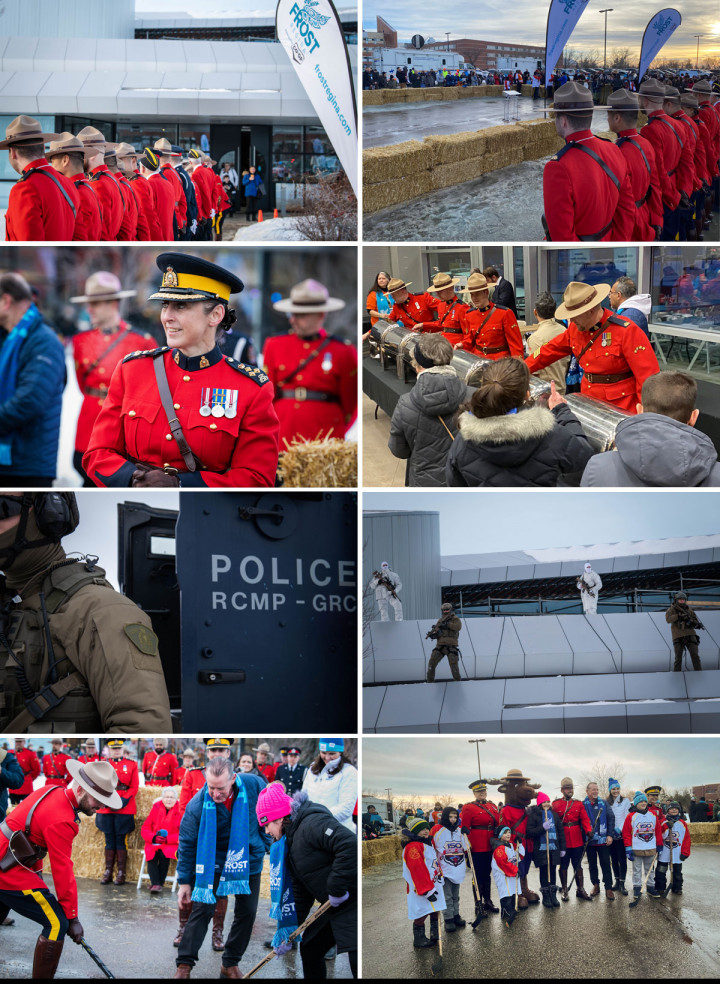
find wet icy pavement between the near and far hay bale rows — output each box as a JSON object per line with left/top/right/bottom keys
{"left": 362, "top": 96, "right": 607, "bottom": 149}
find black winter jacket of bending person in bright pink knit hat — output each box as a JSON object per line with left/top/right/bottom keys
{"left": 286, "top": 792, "right": 357, "bottom": 953}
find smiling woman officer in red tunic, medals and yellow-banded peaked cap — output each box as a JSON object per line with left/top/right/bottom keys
{"left": 83, "top": 253, "right": 278, "bottom": 488}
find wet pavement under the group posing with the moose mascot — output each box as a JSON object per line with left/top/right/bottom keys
{"left": 362, "top": 845, "right": 720, "bottom": 980}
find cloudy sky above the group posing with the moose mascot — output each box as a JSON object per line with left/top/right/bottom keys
{"left": 362, "top": 735, "right": 718, "bottom": 803}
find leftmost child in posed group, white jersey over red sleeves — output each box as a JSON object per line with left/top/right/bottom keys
{"left": 403, "top": 817, "right": 445, "bottom": 949}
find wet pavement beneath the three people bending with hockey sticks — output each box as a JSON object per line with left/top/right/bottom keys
{"left": 0, "top": 878, "right": 351, "bottom": 980}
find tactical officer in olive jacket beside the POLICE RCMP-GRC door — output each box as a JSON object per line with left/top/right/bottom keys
{"left": 0, "top": 492, "right": 172, "bottom": 734}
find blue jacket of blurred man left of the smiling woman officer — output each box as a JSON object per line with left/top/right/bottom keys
{"left": 0, "top": 308, "right": 67, "bottom": 476}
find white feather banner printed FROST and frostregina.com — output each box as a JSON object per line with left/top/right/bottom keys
{"left": 275, "top": 0, "right": 358, "bottom": 195}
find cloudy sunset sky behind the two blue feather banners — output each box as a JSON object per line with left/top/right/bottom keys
{"left": 363, "top": 0, "right": 720, "bottom": 62}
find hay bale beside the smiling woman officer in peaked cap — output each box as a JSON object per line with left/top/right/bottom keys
{"left": 278, "top": 435, "right": 357, "bottom": 489}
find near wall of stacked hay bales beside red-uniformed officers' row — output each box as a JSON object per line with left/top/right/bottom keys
{"left": 363, "top": 117, "right": 563, "bottom": 214}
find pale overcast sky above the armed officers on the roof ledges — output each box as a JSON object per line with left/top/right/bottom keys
{"left": 363, "top": 489, "right": 720, "bottom": 556}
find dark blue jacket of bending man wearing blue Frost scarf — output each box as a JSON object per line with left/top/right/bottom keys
{"left": 177, "top": 773, "right": 270, "bottom": 885}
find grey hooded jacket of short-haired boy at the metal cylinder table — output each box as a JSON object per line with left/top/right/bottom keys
{"left": 580, "top": 413, "right": 720, "bottom": 488}
